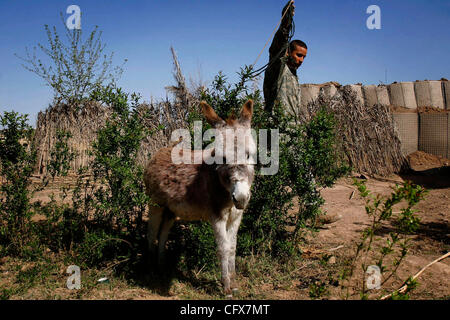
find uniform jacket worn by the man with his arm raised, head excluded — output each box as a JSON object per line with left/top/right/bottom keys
{"left": 263, "top": 0, "right": 307, "bottom": 122}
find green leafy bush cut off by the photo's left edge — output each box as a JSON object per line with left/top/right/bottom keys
{"left": 0, "top": 112, "right": 36, "bottom": 255}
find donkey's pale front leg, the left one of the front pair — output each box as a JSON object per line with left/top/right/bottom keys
{"left": 211, "top": 218, "right": 232, "bottom": 297}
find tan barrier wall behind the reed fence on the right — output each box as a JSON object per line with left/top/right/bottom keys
{"left": 301, "top": 79, "right": 450, "bottom": 158}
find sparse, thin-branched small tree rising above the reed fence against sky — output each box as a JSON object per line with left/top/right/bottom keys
{"left": 16, "top": 15, "right": 127, "bottom": 103}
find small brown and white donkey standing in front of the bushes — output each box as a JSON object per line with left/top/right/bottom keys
{"left": 144, "top": 100, "right": 256, "bottom": 297}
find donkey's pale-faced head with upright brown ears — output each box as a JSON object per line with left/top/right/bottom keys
{"left": 201, "top": 100, "right": 256, "bottom": 209}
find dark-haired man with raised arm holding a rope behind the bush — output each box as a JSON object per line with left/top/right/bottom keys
{"left": 263, "top": 1, "right": 308, "bottom": 122}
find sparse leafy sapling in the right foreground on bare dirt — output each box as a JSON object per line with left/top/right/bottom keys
{"left": 340, "top": 179, "right": 428, "bottom": 299}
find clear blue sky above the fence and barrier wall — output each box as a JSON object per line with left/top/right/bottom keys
{"left": 0, "top": 0, "right": 450, "bottom": 125}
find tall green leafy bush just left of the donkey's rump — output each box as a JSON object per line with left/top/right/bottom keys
{"left": 65, "top": 87, "right": 150, "bottom": 264}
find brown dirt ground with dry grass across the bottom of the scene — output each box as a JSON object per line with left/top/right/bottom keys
{"left": 0, "top": 152, "right": 450, "bottom": 300}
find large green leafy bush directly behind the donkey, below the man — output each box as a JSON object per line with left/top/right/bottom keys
{"left": 171, "top": 67, "right": 349, "bottom": 269}
